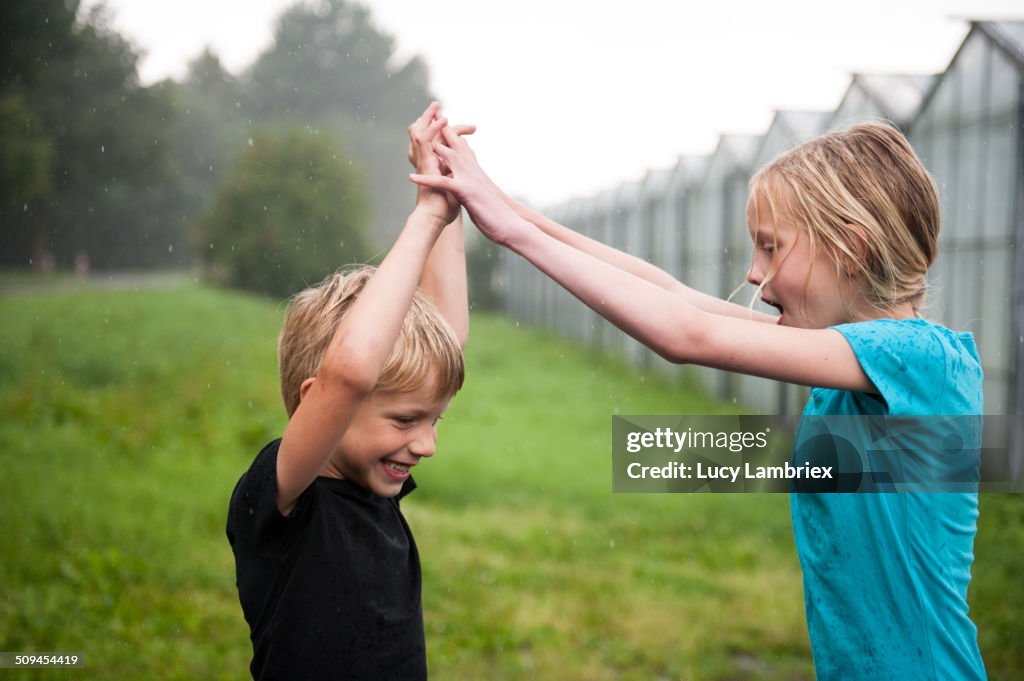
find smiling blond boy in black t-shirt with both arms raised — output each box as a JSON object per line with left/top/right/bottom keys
{"left": 227, "top": 102, "right": 468, "bottom": 681}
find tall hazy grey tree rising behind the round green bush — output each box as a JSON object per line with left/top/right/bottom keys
{"left": 243, "top": 0, "right": 433, "bottom": 244}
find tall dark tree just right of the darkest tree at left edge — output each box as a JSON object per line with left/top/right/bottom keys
{"left": 36, "top": 8, "right": 184, "bottom": 267}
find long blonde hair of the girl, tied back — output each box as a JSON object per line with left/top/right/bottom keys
{"left": 750, "top": 122, "right": 940, "bottom": 312}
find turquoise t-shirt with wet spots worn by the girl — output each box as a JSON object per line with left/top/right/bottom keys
{"left": 791, "top": 320, "right": 985, "bottom": 681}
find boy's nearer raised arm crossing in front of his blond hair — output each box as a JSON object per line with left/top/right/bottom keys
{"left": 276, "top": 121, "right": 459, "bottom": 515}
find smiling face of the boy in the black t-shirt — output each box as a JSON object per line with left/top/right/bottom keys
{"left": 326, "top": 383, "right": 452, "bottom": 497}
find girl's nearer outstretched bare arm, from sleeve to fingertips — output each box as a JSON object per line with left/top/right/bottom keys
{"left": 411, "top": 130, "right": 873, "bottom": 391}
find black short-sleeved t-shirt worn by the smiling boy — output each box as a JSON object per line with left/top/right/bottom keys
{"left": 227, "top": 439, "right": 427, "bottom": 681}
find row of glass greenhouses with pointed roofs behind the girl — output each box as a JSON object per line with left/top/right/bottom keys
{"left": 495, "top": 22, "right": 1024, "bottom": 473}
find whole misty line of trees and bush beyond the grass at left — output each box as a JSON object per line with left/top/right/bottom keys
{"left": 0, "top": 0, "right": 450, "bottom": 295}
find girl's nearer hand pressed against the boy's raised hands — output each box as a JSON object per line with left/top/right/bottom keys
{"left": 409, "top": 127, "right": 531, "bottom": 245}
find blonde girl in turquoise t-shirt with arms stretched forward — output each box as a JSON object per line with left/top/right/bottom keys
{"left": 411, "top": 124, "right": 985, "bottom": 679}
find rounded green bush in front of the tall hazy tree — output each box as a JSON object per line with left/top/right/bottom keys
{"left": 196, "top": 128, "right": 371, "bottom": 297}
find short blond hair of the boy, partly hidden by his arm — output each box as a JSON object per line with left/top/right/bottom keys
{"left": 278, "top": 265, "right": 465, "bottom": 417}
